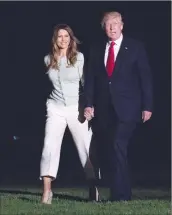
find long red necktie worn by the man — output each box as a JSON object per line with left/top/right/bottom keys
{"left": 106, "top": 41, "right": 115, "bottom": 77}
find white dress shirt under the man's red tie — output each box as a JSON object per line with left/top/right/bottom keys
{"left": 104, "top": 34, "right": 123, "bottom": 66}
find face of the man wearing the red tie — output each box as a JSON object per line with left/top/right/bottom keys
{"left": 105, "top": 16, "right": 123, "bottom": 40}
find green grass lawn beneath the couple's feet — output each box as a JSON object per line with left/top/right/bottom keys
{"left": 0, "top": 188, "right": 171, "bottom": 215}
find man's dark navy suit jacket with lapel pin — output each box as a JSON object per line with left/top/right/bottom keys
{"left": 85, "top": 36, "right": 153, "bottom": 126}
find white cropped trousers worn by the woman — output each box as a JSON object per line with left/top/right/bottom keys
{"left": 40, "top": 100, "right": 95, "bottom": 179}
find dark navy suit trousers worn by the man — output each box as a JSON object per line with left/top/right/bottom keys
{"left": 92, "top": 101, "right": 136, "bottom": 201}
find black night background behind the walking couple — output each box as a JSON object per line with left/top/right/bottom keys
{"left": 0, "top": 1, "right": 171, "bottom": 186}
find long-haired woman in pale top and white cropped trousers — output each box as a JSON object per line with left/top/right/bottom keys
{"left": 40, "top": 24, "right": 98, "bottom": 204}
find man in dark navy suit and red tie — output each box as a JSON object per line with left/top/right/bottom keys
{"left": 84, "top": 12, "right": 153, "bottom": 201}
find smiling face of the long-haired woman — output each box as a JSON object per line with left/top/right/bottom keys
{"left": 57, "top": 29, "right": 70, "bottom": 49}
